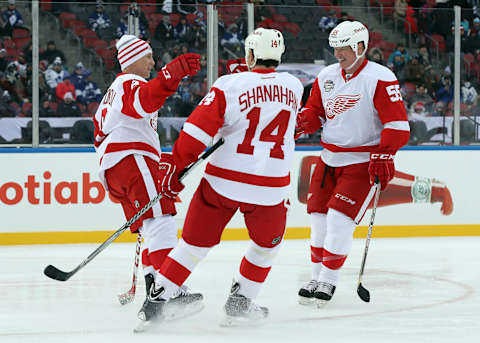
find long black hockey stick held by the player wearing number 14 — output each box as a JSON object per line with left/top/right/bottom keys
{"left": 43, "top": 138, "right": 224, "bottom": 281}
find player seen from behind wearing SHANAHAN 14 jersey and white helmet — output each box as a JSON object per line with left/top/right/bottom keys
{"left": 139, "top": 28, "right": 303, "bottom": 325}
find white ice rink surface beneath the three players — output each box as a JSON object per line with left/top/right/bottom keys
{"left": 0, "top": 237, "right": 480, "bottom": 343}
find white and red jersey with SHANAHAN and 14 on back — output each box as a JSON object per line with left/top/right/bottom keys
{"left": 174, "top": 69, "right": 303, "bottom": 205}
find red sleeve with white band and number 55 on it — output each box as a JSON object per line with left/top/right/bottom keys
{"left": 373, "top": 80, "right": 410, "bottom": 154}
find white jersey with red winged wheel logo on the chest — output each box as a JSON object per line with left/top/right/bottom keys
{"left": 303, "top": 60, "right": 410, "bottom": 166}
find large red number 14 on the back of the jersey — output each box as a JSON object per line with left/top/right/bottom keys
{"left": 237, "top": 107, "right": 290, "bottom": 160}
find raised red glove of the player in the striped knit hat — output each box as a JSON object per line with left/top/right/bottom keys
{"left": 160, "top": 53, "right": 200, "bottom": 89}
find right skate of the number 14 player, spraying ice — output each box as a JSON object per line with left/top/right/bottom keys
{"left": 220, "top": 282, "right": 268, "bottom": 327}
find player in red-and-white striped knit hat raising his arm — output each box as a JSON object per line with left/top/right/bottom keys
{"left": 93, "top": 35, "right": 202, "bottom": 330}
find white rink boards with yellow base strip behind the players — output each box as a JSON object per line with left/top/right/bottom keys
{"left": 0, "top": 147, "right": 480, "bottom": 245}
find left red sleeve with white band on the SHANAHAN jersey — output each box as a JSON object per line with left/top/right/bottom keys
{"left": 173, "top": 87, "right": 226, "bottom": 170}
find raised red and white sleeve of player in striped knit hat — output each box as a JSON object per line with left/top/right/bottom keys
{"left": 122, "top": 77, "right": 175, "bottom": 119}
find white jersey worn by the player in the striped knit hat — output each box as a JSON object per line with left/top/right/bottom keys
{"left": 93, "top": 73, "right": 173, "bottom": 187}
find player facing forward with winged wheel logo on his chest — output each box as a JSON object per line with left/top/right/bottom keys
{"left": 296, "top": 21, "right": 410, "bottom": 306}
